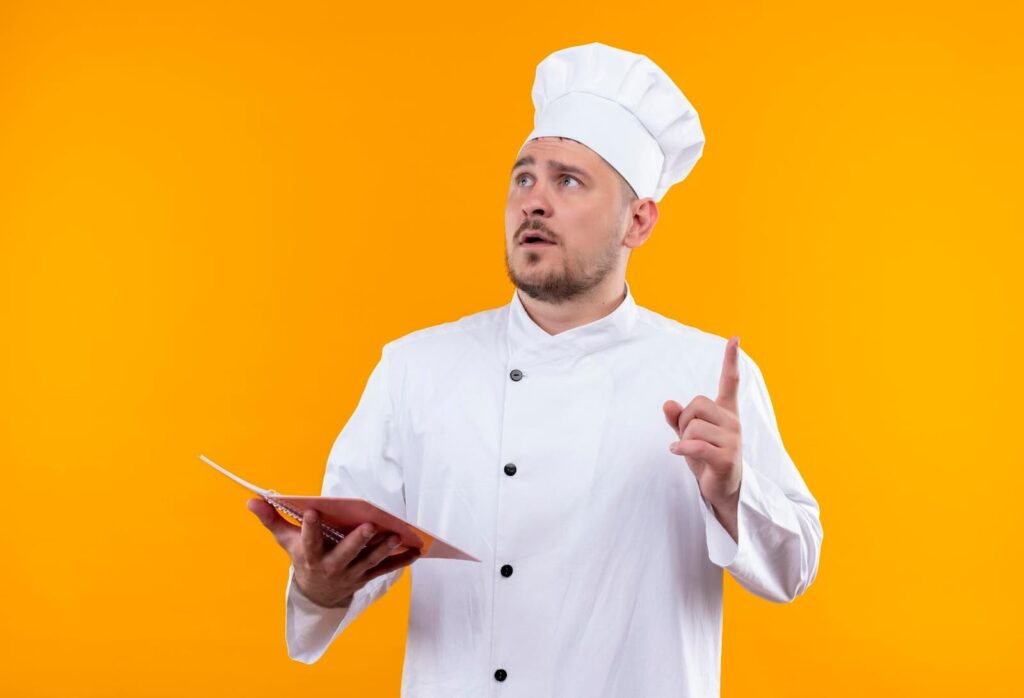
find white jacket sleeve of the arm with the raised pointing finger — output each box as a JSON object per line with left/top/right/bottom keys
{"left": 698, "top": 350, "right": 823, "bottom": 603}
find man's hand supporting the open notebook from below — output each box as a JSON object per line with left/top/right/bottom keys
{"left": 248, "top": 499, "right": 420, "bottom": 608}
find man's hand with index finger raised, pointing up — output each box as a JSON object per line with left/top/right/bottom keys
{"left": 663, "top": 337, "right": 743, "bottom": 507}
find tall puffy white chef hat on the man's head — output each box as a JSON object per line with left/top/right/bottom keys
{"left": 523, "top": 43, "right": 705, "bottom": 202}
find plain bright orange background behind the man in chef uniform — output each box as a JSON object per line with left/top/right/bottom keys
{"left": 0, "top": 1, "right": 1024, "bottom": 698}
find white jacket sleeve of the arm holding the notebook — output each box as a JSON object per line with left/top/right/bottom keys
{"left": 285, "top": 345, "right": 406, "bottom": 664}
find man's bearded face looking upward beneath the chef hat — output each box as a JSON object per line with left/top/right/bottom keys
{"left": 505, "top": 137, "right": 631, "bottom": 304}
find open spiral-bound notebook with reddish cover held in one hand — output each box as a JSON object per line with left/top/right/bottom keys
{"left": 199, "top": 455, "right": 480, "bottom": 562}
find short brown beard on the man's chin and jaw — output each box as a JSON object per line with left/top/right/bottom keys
{"left": 505, "top": 224, "right": 622, "bottom": 305}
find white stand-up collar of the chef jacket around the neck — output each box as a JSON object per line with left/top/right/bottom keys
{"left": 508, "top": 283, "right": 637, "bottom": 361}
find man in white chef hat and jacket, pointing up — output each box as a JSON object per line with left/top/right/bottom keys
{"left": 250, "top": 43, "right": 822, "bottom": 698}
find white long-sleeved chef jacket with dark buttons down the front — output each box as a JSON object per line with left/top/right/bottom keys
{"left": 286, "top": 287, "right": 822, "bottom": 698}
